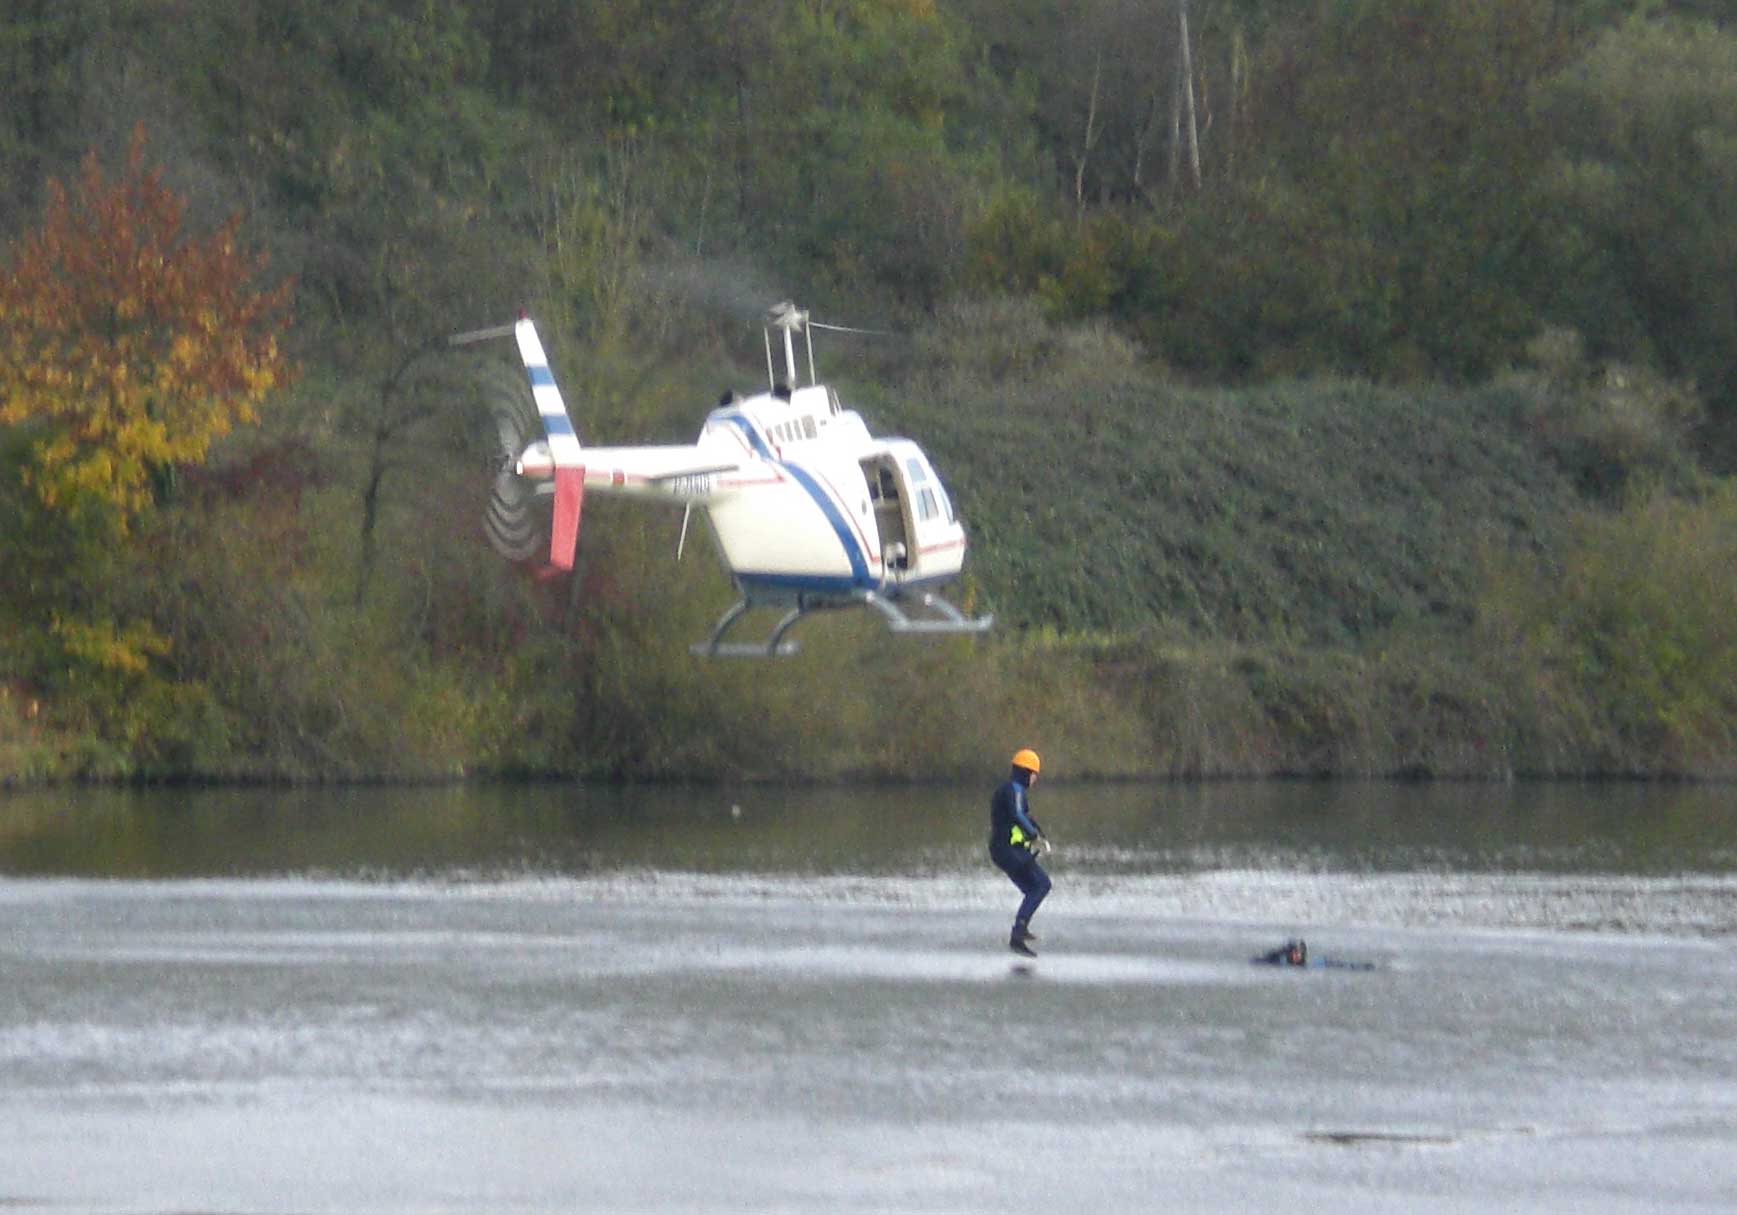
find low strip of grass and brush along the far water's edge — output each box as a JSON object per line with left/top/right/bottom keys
{"left": 0, "top": 495, "right": 1737, "bottom": 782}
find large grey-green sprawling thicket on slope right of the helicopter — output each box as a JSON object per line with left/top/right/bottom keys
{"left": 889, "top": 301, "right": 1575, "bottom": 645}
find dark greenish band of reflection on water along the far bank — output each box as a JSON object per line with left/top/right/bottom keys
{"left": 0, "top": 780, "right": 1737, "bottom": 878}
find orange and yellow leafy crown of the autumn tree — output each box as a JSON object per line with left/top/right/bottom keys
{"left": 0, "top": 127, "right": 288, "bottom": 527}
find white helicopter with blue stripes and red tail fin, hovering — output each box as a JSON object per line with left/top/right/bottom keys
{"left": 450, "top": 301, "right": 994, "bottom": 657}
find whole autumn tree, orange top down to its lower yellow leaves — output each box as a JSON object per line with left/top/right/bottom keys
{"left": 0, "top": 127, "right": 288, "bottom": 773}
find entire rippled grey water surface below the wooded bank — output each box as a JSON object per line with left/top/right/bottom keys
{"left": 0, "top": 782, "right": 1737, "bottom": 1215}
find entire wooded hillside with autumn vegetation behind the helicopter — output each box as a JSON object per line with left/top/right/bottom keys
{"left": 0, "top": 0, "right": 1737, "bottom": 780}
